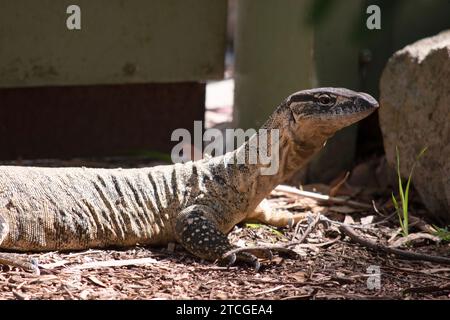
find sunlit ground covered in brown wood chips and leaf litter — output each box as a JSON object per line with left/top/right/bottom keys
{"left": 0, "top": 156, "right": 450, "bottom": 300}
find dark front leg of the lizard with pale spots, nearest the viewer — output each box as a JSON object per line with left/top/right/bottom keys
{"left": 175, "top": 205, "right": 259, "bottom": 269}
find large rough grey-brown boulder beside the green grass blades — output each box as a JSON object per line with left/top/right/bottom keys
{"left": 380, "top": 30, "right": 450, "bottom": 222}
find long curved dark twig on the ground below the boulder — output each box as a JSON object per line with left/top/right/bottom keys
{"left": 339, "top": 225, "right": 450, "bottom": 264}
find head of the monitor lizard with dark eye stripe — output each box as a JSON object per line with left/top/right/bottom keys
{"left": 284, "top": 88, "right": 378, "bottom": 143}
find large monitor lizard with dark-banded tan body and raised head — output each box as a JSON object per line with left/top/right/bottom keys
{"left": 0, "top": 88, "right": 378, "bottom": 270}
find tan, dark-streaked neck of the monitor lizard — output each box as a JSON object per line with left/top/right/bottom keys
{"left": 213, "top": 110, "right": 328, "bottom": 212}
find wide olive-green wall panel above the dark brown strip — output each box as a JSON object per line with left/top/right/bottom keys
{"left": 0, "top": 0, "right": 227, "bottom": 87}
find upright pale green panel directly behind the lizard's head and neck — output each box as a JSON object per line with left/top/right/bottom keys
{"left": 234, "top": 0, "right": 314, "bottom": 128}
